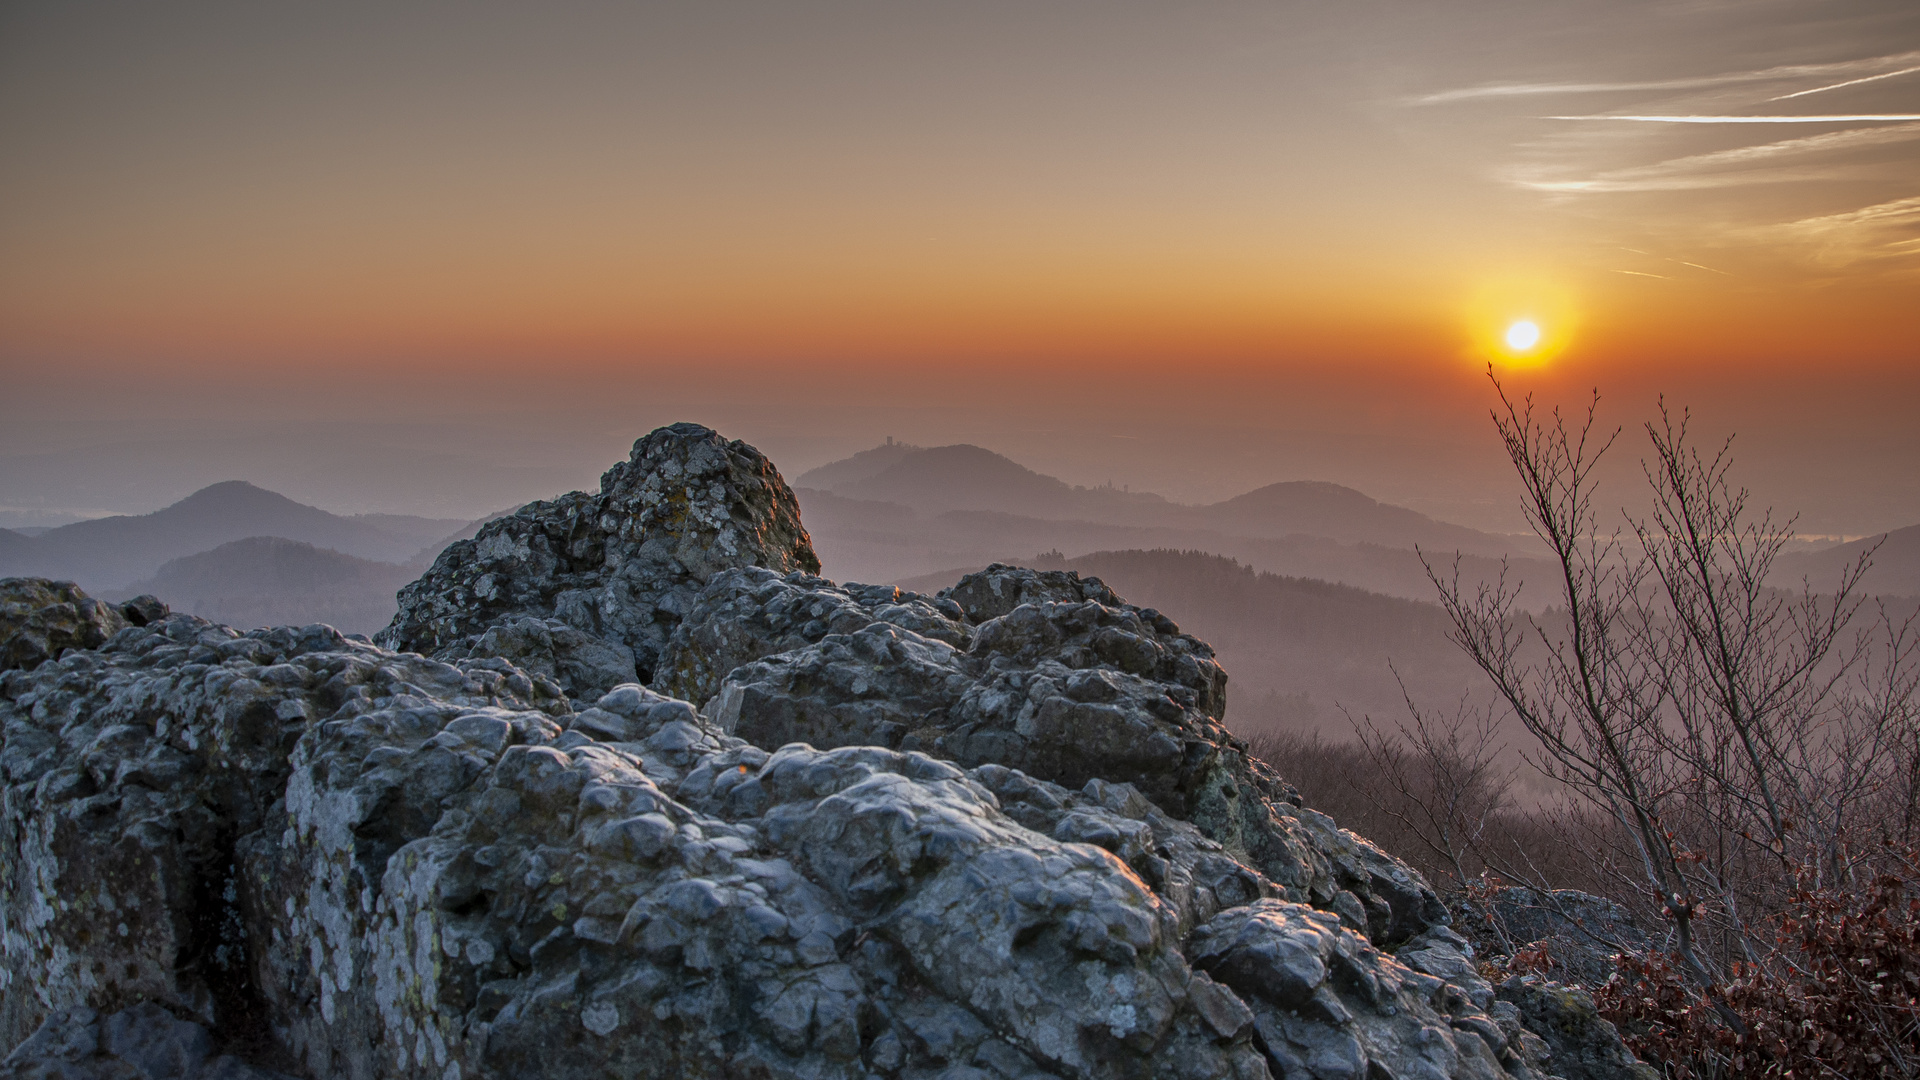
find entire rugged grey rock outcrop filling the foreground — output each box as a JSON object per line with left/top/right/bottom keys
{"left": 0, "top": 425, "right": 1644, "bottom": 1080}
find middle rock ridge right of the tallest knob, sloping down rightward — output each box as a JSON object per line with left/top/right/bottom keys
{"left": 698, "top": 565, "right": 1446, "bottom": 944}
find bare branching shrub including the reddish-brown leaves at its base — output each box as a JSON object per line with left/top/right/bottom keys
{"left": 1428, "top": 372, "right": 1920, "bottom": 1076}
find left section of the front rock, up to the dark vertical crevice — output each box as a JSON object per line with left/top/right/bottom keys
{"left": 0, "top": 615, "right": 564, "bottom": 1045}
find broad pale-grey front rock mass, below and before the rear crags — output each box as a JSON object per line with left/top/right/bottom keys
{"left": 0, "top": 615, "right": 1267, "bottom": 1080}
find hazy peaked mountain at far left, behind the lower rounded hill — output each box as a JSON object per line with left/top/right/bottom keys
{"left": 0, "top": 480, "right": 472, "bottom": 592}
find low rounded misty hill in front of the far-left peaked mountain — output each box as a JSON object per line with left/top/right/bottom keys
{"left": 125, "top": 536, "right": 415, "bottom": 634}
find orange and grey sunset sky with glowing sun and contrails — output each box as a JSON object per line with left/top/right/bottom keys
{"left": 0, "top": 0, "right": 1920, "bottom": 534}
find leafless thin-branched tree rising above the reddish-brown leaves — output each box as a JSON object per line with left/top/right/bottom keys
{"left": 1427, "top": 372, "right": 1920, "bottom": 992}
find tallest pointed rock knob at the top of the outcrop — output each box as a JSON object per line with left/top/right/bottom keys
{"left": 378, "top": 423, "right": 820, "bottom": 698}
